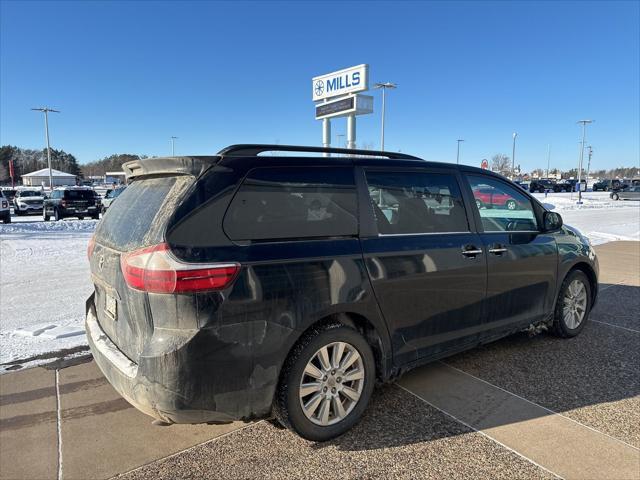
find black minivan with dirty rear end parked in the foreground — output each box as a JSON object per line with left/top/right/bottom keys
{"left": 86, "top": 145, "right": 598, "bottom": 441}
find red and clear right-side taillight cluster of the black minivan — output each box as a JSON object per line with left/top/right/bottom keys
{"left": 120, "top": 243, "right": 240, "bottom": 293}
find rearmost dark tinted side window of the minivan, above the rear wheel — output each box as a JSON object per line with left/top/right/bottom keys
{"left": 223, "top": 167, "right": 358, "bottom": 240}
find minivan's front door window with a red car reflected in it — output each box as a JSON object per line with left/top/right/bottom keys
{"left": 467, "top": 175, "right": 538, "bottom": 232}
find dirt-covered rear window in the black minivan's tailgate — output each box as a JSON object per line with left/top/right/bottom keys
{"left": 96, "top": 176, "right": 193, "bottom": 251}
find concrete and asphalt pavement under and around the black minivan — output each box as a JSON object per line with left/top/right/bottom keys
{"left": 0, "top": 242, "right": 640, "bottom": 479}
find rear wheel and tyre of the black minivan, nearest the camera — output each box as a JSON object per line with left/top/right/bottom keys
{"left": 274, "top": 324, "right": 375, "bottom": 442}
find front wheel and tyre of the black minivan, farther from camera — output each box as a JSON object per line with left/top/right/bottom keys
{"left": 551, "top": 270, "right": 591, "bottom": 338}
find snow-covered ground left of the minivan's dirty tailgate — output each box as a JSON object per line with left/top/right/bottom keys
{"left": 0, "top": 216, "right": 97, "bottom": 370}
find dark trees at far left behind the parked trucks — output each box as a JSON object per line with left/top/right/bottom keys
{"left": 0, "top": 145, "right": 82, "bottom": 183}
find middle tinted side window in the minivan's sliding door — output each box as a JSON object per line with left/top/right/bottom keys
{"left": 367, "top": 171, "right": 469, "bottom": 234}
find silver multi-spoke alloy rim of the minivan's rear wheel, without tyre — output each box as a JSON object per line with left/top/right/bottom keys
{"left": 299, "top": 342, "right": 365, "bottom": 426}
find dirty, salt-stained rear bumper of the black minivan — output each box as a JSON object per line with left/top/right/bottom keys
{"left": 86, "top": 295, "right": 241, "bottom": 423}
